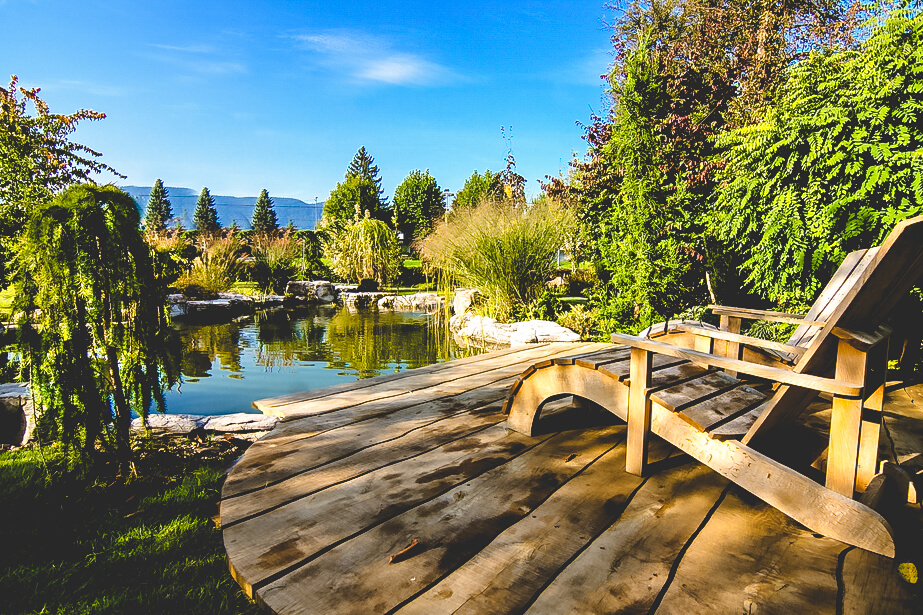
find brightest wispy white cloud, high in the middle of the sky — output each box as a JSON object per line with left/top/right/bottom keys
{"left": 291, "top": 30, "right": 459, "bottom": 86}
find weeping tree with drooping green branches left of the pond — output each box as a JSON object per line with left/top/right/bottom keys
{"left": 16, "top": 185, "right": 178, "bottom": 476}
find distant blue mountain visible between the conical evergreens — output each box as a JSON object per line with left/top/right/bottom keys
{"left": 120, "top": 186, "right": 324, "bottom": 230}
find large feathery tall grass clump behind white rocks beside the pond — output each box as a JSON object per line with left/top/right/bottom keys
{"left": 421, "top": 199, "right": 577, "bottom": 321}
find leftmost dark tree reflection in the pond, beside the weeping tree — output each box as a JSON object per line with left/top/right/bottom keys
{"left": 176, "top": 322, "right": 241, "bottom": 378}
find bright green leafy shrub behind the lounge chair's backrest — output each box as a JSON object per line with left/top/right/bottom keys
{"left": 710, "top": 8, "right": 923, "bottom": 305}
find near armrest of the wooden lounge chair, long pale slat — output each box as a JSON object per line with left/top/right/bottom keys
{"left": 611, "top": 333, "right": 862, "bottom": 397}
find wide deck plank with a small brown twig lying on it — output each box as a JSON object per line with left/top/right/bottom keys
{"left": 253, "top": 426, "right": 624, "bottom": 614}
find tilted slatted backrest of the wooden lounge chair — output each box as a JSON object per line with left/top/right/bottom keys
{"left": 743, "top": 216, "right": 923, "bottom": 443}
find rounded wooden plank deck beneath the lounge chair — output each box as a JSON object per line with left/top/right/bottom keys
{"left": 220, "top": 344, "right": 923, "bottom": 615}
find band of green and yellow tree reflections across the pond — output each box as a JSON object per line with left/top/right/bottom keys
{"left": 177, "top": 307, "right": 490, "bottom": 378}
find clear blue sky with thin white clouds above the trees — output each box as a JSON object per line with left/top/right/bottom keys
{"left": 7, "top": 0, "right": 611, "bottom": 202}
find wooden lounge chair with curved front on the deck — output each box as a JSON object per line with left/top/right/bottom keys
{"left": 506, "top": 217, "right": 923, "bottom": 557}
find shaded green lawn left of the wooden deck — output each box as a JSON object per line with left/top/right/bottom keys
{"left": 0, "top": 443, "right": 260, "bottom": 615}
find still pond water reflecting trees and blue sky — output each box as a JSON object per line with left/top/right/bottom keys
{"left": 166, "top": 307, "right": 478, "bottom": 414}
